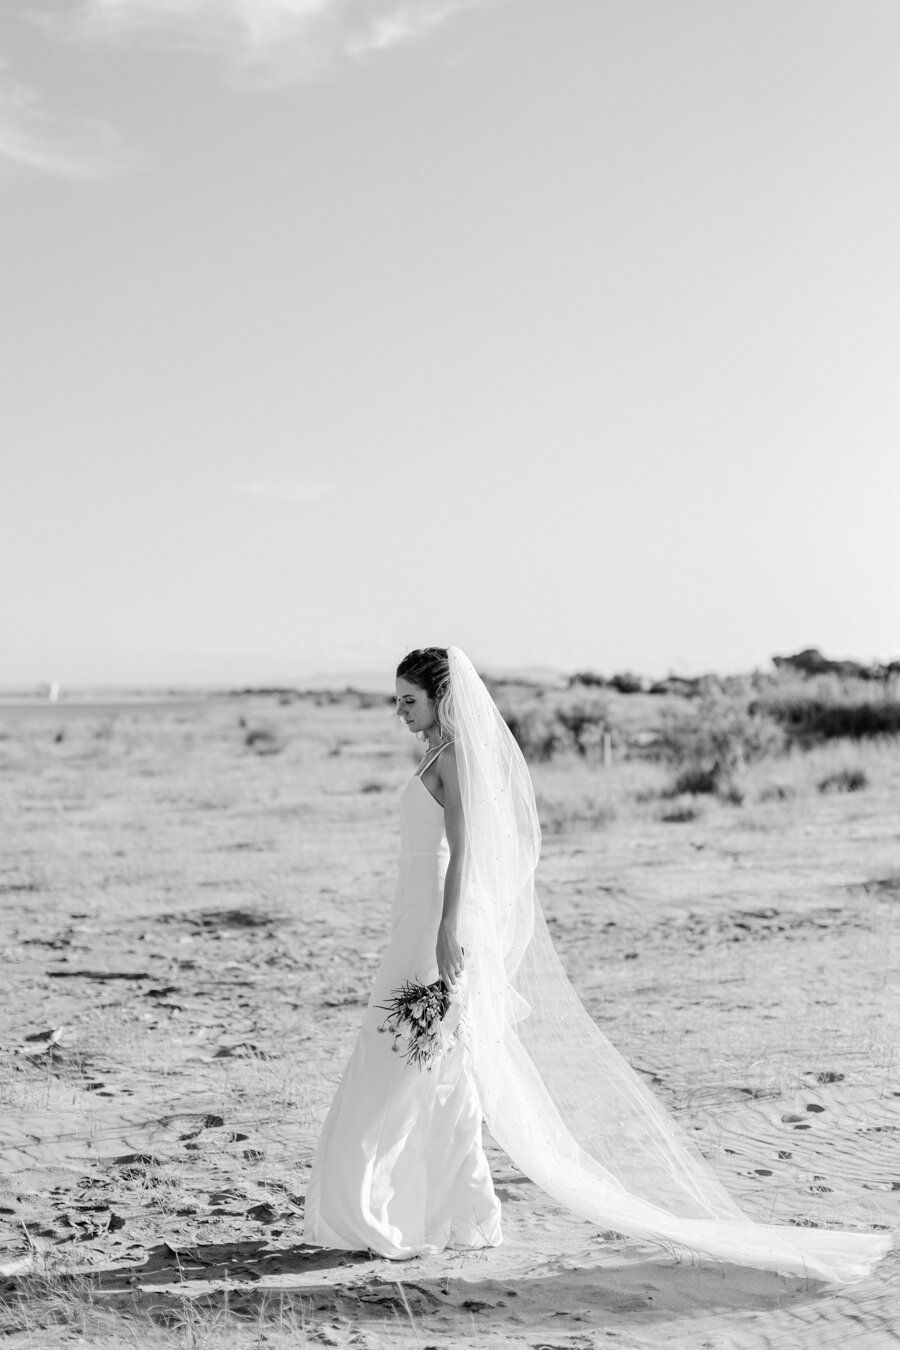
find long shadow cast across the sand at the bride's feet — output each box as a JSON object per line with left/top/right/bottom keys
{"left": 54, "top": 1241, "right": 863, "bottom": 1345}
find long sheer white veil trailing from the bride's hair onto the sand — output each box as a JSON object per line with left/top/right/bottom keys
{"left": 448, "top": 647, "right": 892, "bottom": 1283}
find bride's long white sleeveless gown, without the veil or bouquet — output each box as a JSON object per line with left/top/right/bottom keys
{"left": 305, "top": 751, "right": 501, "bottom": 1260}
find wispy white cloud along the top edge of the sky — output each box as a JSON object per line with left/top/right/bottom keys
{"left": 32, "top": 0, "right": 495, "bottom": 84}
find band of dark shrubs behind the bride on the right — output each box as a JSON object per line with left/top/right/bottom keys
{"left": 495, "top": 648, "right": 900, "bottom": 818}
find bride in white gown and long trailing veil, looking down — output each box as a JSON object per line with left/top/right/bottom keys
{"left": 305, "top": 647, "right": 891, "bottom": 1283}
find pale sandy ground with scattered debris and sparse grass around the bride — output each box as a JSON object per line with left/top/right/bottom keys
{"left": 0, "top": 698, "right": 900, "bottom": 1350}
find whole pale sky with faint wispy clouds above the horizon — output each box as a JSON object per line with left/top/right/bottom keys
{"left": 0, "top": 0, "right": 900, "bottom": 684}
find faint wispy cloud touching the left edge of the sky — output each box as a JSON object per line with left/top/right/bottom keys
{"left": 0, "top": 57, "right": 134, "bottom": 178}
